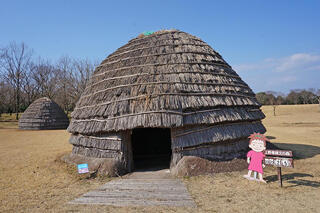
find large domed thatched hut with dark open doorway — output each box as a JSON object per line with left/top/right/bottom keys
{"left": 68, "top": 30, "right": 265, "bottom": 176}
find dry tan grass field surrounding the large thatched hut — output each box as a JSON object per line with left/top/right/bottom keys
{"left": 0, "top": 105, "right": 320, "bottom": 212}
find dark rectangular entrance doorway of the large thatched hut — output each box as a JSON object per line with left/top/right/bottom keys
{"left": 131, "top": 128, "right": 171, "bottom": 170}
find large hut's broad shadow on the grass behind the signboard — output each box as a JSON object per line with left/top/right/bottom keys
{"left": 273, "top": 143, "right": 320, "bottom": 159}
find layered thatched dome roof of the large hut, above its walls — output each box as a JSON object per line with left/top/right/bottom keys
{"left": 68, "top": 30, "right": 264, "bottom": 134}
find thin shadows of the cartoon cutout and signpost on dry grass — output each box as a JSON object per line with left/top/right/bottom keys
{"left": 265, "top": 173, "right": 320, "bottom": 188}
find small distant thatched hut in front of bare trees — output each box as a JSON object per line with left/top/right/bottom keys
{"left": 19, "top": 98, "right": 69, "bottom": 130}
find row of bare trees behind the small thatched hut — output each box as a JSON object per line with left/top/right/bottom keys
{"left": 0, "top": 42, "right": 97, "bottom": 119}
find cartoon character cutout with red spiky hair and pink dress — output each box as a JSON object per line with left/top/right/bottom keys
{"left": 244, "top": 133, "right": 267, "bottom": 183}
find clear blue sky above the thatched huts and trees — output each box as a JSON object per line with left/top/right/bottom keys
{"left": 0, "top": 0, "right": 320, "bottom": 93}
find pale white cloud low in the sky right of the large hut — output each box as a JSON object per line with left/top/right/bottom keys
{"left": 233, "top": 53, "right": 320, "bottom": 91}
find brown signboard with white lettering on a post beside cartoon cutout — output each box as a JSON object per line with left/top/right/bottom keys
{"left": 264, "top": 149, "right": 293, "bottom": 187}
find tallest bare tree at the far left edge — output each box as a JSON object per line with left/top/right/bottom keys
{"left": 0, "top": 42, "right": 32, "bottom": 120}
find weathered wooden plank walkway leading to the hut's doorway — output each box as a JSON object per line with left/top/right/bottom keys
{"left": 70, "top": 179, "right": 195, "bottom": 207}
